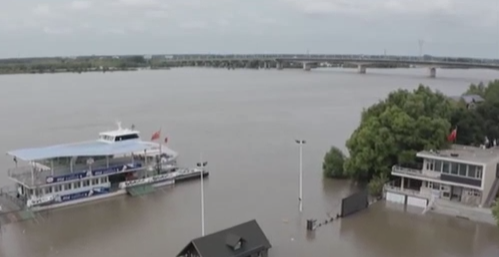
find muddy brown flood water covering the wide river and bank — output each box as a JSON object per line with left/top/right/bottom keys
{"left": 0, "top": 68, "right": 499, "bottom": 257}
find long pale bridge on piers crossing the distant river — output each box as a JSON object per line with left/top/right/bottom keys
{"left": 161, "top": 54, "right": 499, "bottom": 77}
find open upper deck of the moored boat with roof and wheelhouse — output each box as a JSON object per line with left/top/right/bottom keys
{"left": 7, "top": 124, "right": 178, "bottom": 186}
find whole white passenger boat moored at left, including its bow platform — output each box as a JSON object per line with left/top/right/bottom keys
{"left": 4, "top": 124, "right": 208, "bottom": 211}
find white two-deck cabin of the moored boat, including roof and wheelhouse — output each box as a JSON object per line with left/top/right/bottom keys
{"left": 8, "top": 124, "right": 177, "bottom": 208}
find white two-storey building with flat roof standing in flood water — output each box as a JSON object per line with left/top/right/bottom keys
{"left": 384, "top": 145, "right": 499, "bottom": 208}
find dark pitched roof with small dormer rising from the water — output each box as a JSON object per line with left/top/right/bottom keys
{"left": 177, "top": 220, "right": 272, "bottom": 257}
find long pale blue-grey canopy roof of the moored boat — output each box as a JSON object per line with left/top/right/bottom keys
{"left": 7, "top": 140, "right": 174, "bottom": 161}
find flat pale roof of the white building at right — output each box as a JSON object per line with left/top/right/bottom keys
{"left": 417, "top": 145, "right": 499, "bottom": 165}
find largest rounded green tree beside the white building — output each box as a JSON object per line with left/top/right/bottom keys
{"left": 344, "top": 86, "right": 455, "bottom": 180}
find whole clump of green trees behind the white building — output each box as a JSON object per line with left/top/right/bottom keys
{"left": 323, "top": 80, "right": 499, "bottom": 224}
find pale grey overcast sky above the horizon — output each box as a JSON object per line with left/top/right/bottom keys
{"left": 0, "top": 0, "right": 499, "bottom": 58}
